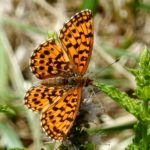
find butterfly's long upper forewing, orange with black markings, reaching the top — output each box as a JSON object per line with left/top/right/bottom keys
{"left": 59, "top": 10, "right": 93, "bottom": 75}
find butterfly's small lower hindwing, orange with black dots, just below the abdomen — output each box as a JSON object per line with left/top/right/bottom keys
{"left": 24, "top": 85, "right": 66, "bottom": 112}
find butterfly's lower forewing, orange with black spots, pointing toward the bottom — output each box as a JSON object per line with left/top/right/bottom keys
{"left": 41, "top": 87, "right": 81, "bottom": 140}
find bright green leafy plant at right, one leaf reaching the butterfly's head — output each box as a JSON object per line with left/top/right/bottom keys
{"left": 90, "top": 48, "right": 150, "bottom": 150}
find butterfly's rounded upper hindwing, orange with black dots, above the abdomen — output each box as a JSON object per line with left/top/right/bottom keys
{"left": 30, "top": 39, "right": 73, "bottom": 79}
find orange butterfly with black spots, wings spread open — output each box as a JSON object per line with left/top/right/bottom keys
{"left": 24, "top": 9, "right": 93, "bottom": 141}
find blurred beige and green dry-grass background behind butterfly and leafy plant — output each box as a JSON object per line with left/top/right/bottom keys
{"left": 0, "top": 0, "right": 150, "bottom": 150}
